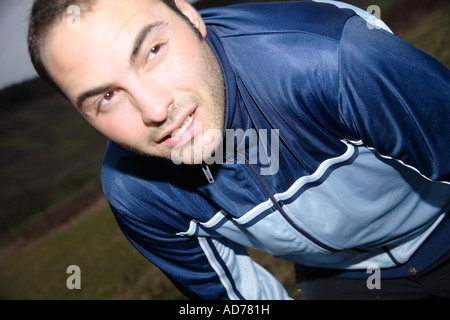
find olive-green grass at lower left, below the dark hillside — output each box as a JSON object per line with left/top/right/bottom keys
{"left": 0, "top": 202, "right": 298, "bottom": 300}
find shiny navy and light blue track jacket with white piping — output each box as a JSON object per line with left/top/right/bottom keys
{"left": 102, "top": 1, "right": 450, "bottom": 299}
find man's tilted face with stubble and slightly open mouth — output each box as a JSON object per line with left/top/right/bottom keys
{"left": 42, "top": 0, "right": 225, "bottom": 163}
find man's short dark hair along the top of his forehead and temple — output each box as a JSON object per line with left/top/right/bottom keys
{"left": 27, "top": 0, "right": 186, "bottom": 91}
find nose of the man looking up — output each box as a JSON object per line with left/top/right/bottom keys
{"left": 131, "top": 84, "right": 173, "bottom": 125}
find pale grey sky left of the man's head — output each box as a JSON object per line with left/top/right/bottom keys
{"left": 0, "top": 0, "right": 199, "bottom": 89}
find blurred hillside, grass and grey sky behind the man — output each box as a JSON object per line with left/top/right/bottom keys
{"left": 0, "top": 0, "right": 450, "bottom": 300}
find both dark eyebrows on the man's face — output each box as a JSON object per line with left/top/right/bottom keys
{"left": 76, "top": 21, "right": 167, "bottom": 110}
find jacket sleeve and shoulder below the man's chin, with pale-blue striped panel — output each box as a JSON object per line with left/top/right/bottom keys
{"left": 101, "top": 141, "right": 290, "bottom": 300}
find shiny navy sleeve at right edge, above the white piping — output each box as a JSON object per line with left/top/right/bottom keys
{"left": 337, "top": 16, "right": 450, "bottom": 183}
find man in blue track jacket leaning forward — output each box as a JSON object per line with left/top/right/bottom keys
{"left": 29, "top": 0, "right": 450, "bottom": 299}
